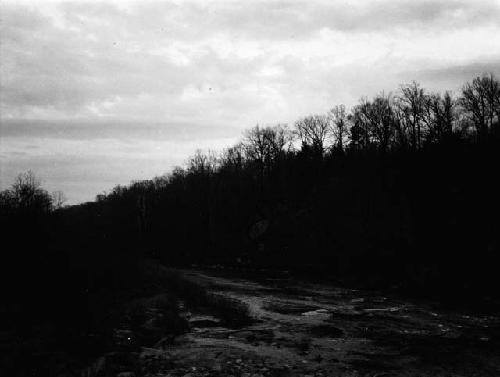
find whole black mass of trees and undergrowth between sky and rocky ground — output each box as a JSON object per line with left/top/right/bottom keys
{"left": 0, "top": 75, "right": 500, "bottom": 375}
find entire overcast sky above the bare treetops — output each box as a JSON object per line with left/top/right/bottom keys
{"left": 0, "top": 0, "right": 500, "bottom": 204}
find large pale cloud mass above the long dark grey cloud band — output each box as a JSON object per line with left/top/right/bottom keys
{"left": 0, "top": 1, "right": 500, "bottom": 122}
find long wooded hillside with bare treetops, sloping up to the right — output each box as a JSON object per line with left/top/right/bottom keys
{"left": 61, "top": 75, "right": 500, "bottom": 294}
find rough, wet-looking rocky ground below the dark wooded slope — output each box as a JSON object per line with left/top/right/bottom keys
{"left": 141, "top": 271, "right": 500, "bottom": 377}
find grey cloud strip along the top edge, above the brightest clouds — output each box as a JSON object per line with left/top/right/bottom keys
{"left": 106, "top": 0, "right": 500, "bottom": 40}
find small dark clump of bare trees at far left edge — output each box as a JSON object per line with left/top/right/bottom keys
{"left": 0, "top": 171, "right": 68, "bottom": 319}
